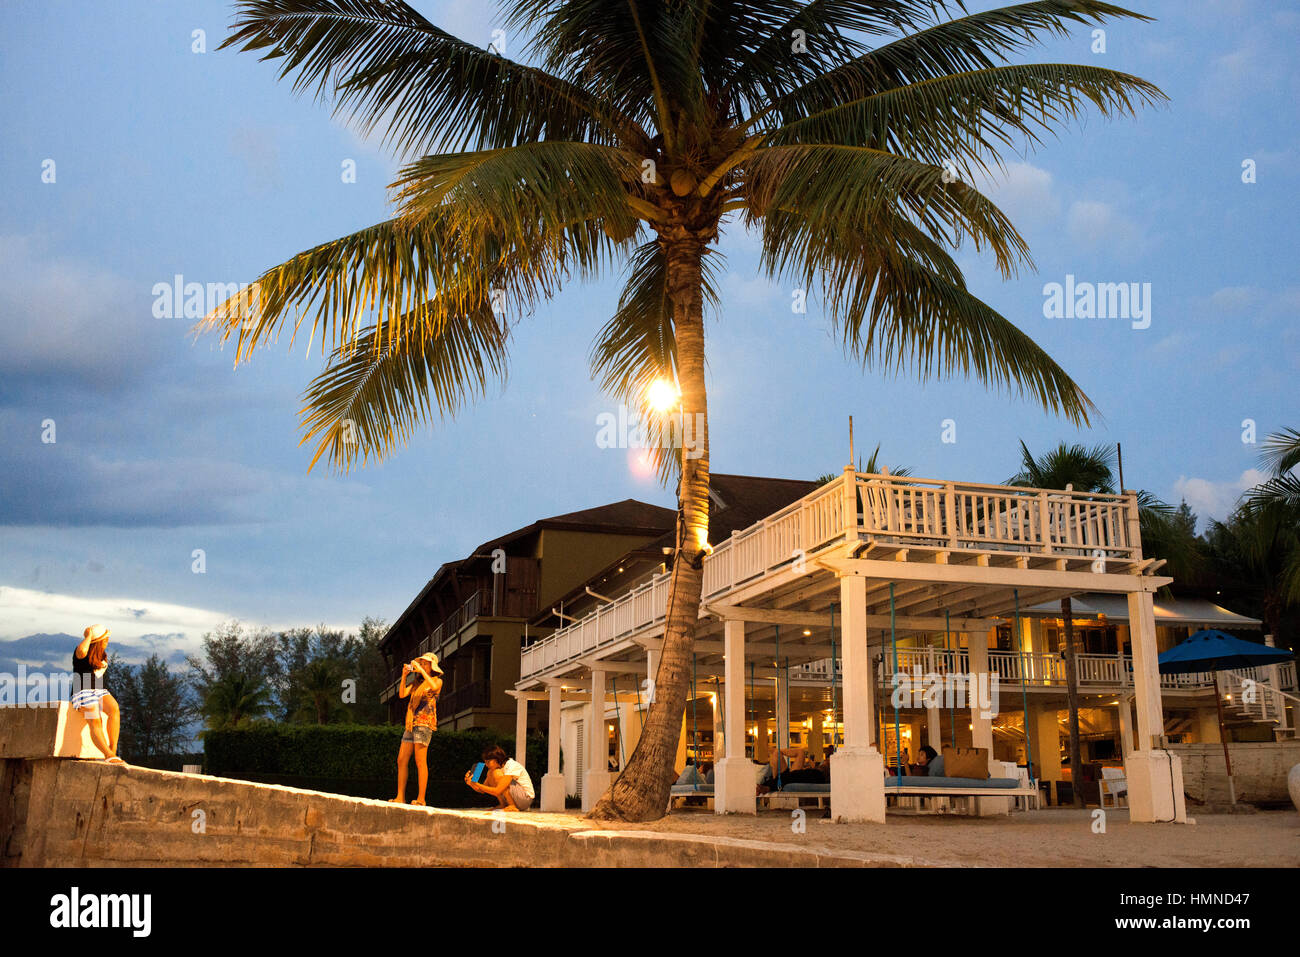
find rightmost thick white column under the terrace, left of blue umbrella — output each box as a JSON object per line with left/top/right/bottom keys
{"left": 1125, "top": 592, "right": 1187, "bottom": 823}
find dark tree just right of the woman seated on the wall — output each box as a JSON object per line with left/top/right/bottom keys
{"left": 111, "top": 654, "right": 195, "bottom": 765}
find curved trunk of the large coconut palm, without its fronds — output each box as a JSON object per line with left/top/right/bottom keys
{"left": 590, "top": 238, "right": 709, "bottom": 820}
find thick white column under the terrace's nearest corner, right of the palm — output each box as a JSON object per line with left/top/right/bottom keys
{"left": 831, "top": 575, "right": 885, "bottom": 823}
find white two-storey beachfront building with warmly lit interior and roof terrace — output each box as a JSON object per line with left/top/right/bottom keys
{"left": 514, "top": 469, "right": 1296, "bottom": 820}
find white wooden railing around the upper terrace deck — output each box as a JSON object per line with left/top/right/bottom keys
{"left": 520, "top": 472, "right": 1141, "bottom": 683}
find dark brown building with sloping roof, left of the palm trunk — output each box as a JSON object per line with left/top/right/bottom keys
{"left": 380, "top": 498, "right": 676, "bottom": 731}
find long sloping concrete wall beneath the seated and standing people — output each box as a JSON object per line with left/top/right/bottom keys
{"left": 0, "top": 758, "right": 894, "bottom": 867}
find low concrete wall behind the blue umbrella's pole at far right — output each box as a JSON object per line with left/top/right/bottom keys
{"left": 1169, "top": 741, "right": 1300, "bottom": 804}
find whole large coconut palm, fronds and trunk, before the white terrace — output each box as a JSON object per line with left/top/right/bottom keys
{"left": 204, "top": 0, "right": 1164, "bottom": 820}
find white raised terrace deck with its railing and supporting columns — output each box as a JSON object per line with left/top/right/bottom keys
{"left": 515, "top": 468, "right": 1186, "bottom": 822}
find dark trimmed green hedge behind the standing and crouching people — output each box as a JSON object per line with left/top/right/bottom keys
{"left": 203, "top": 722, "right": 546, "bottom": 806}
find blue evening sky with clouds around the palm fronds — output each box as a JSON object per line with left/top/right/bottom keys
{"left": 0, "top": 0, "right": 1300, "bottom": 657}
